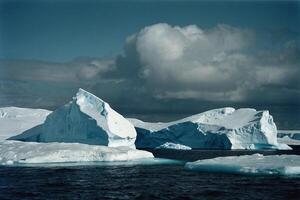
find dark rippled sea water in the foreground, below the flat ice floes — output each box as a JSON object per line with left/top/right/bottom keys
{"left": 0, "top": 164, "right": 300, "bottom": 200}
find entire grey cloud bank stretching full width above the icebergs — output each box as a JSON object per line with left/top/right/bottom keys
{"left": 0, "top": 23, "right": 300, "bottom": 112}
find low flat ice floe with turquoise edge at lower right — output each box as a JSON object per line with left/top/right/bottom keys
{"left": 185, "top": 154, "right": 300, "bottom": 175}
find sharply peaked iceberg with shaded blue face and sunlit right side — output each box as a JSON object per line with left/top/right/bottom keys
{"left": 10, "top": 89, "right": 136, "bottom": 147}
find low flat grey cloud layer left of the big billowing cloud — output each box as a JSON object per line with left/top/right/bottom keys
{"left": 0, "top": 58, "right": 119, "bottom": 109}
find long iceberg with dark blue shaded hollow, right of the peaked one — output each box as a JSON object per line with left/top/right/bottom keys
{"left": 129, "top": 107, "right": 290, "bottom": 149}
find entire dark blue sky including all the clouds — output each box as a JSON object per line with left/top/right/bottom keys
{"left": 0, "top": 0, "right": 300, "bottom": 129}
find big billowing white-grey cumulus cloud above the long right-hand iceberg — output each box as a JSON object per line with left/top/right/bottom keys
{"left": 119, "top": 24, "right": 300, "bottom": 102}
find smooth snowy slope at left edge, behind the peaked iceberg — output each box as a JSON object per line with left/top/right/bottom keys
{"left": 0, "top": 107, "right": 51, "bottom": 141}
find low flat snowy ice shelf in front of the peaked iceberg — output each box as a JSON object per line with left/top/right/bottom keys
{"left": 0, "top": 140, "right": 153, "bottom": 165}
